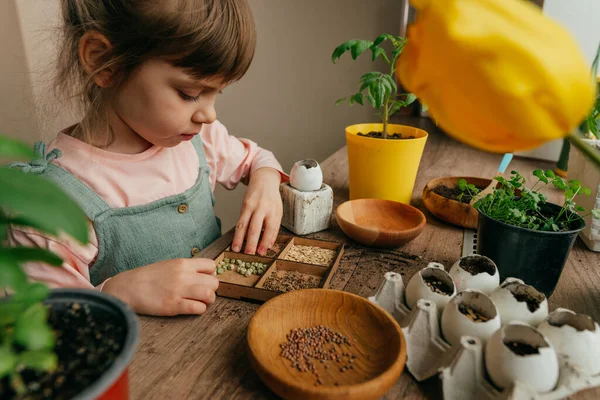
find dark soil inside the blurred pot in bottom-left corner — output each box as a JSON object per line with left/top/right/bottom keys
{"left": 0, "top": 302, "right": 125, "bottom": 400}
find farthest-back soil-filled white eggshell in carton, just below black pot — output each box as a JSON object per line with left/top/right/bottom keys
{"left": 449, "top": 254, "right": 500, "bottom": 295}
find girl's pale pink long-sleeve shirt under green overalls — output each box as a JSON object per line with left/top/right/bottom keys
{"left": 9, "top": 121, "right": 285, "bottom": 289}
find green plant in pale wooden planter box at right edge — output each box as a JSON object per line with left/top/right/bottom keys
{"left": 559, "top": 47, "right": 600, "bottom": 252}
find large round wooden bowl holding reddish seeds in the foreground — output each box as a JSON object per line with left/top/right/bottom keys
{"left": 248, "top": 289, "right": 406, "bottom": 400}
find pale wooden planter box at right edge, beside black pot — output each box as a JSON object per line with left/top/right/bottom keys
{"left": 569, "top": 140, "right": 600, "bottom": 252}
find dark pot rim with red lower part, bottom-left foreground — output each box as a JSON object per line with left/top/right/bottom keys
{"left": 45, "top": 289, "right": 139, "bottom": 400}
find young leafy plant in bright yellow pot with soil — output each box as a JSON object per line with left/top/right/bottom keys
{"left": 331, "top": 34, "right": 427, "bottom": 204}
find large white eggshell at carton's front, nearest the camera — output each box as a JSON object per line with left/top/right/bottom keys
{"left": 485, "top": 323, "right": 559, "bottom": 393}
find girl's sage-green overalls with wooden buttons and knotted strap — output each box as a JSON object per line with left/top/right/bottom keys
{"left": 14, "top": 136, "right": 221, "bottom": 286}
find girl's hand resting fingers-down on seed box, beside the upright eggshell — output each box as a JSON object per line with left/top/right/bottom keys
{"left": 231, "top": 167, "right": 283, "bottom": 256}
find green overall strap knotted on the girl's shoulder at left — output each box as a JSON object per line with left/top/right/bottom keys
{"left": 10, "top": 142, "right": 110, "bottom": 221}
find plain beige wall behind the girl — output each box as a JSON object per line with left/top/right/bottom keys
{"left": 0, "top": 0, "right": 401, "bottom": 229}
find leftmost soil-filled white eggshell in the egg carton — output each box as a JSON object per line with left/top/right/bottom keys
{"left": 405, "top": 263, "right": 456, "bottom": 313}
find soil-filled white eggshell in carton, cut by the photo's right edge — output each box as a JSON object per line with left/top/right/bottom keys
{"left": 538, "top": 309, "right": 600, "bottom": 375}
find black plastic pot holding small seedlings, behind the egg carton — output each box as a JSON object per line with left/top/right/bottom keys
{"left": 477, "top": 203, "right": 585, "bottom": 297}
